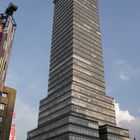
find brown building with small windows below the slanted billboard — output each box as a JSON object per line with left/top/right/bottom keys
{"left": 0, "top": 86, "right": 16, "bottom": 140}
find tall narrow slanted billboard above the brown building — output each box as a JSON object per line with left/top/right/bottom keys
{"left": 0, "top": 17, "right": 15, "bottom": 91}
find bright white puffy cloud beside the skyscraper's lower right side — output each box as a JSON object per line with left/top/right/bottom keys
{"left": 115, "top": 103, "right": 140, "bottom": 140}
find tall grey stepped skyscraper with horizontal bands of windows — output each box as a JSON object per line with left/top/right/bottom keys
{"left": 27, "top": 0, "right": 129, "bottom": 140}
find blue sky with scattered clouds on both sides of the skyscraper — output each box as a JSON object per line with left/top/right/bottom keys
{"left": 0, "top": 0, "right": 140, "bottom": 140}
